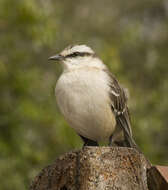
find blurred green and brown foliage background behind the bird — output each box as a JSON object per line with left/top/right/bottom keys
{"left": 0, "top": 0, "right": 168, "bottom": 190}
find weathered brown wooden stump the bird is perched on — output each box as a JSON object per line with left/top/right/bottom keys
{"left": 30, "top": 147, "right": 149, "bottom": 190}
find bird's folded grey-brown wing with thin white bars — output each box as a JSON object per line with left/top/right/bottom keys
{"left": 105, "top": 70, "right": 137, "bottom": 148}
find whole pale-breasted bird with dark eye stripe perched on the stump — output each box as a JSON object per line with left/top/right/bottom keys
{"left": 48, "top": 45, "right": 137, "bottom": 149}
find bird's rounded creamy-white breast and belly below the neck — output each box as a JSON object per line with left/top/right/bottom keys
{"left": 55, "top": 69, "right": 116, "bottom": 141}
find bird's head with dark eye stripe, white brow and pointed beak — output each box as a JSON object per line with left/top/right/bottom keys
{"left": 49, "top": 45, "right": 104, "bottom": 70}
